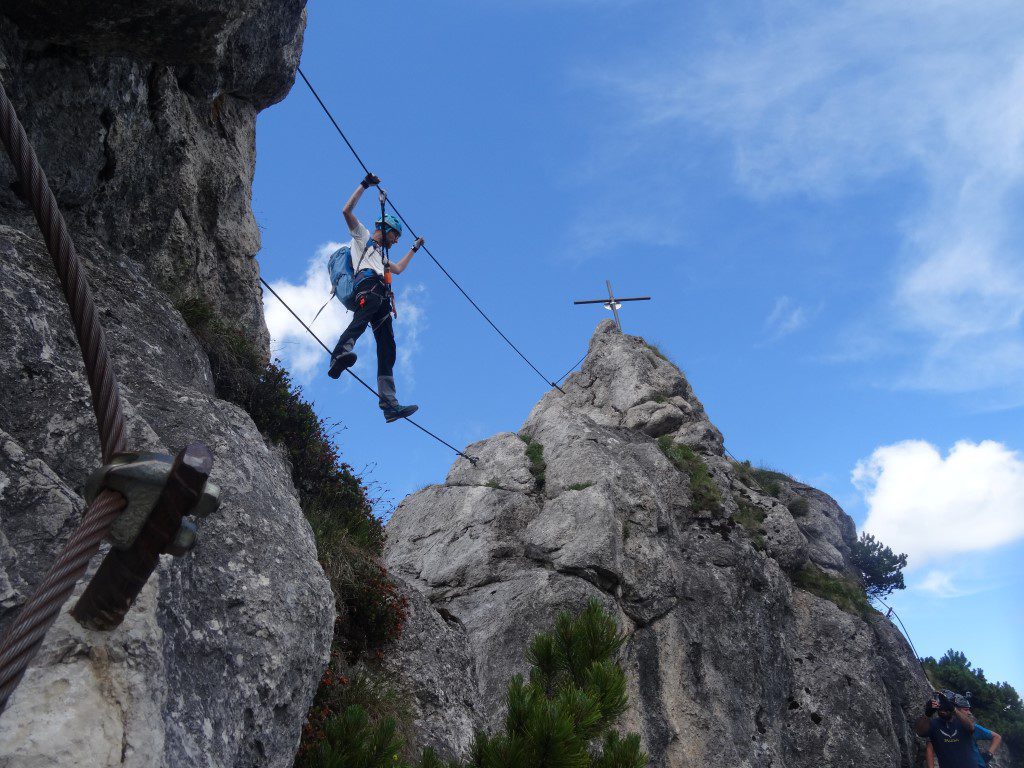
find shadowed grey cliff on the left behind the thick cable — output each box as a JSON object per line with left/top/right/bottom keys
{"left": 0, "top": 0, "right": 334, "bottom": 766}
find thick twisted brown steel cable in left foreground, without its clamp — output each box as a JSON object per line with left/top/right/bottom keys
{"left": 0, "top": 84, "right": 126, "bottom": 712}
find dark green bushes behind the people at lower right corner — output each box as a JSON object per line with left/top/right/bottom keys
{"left": 921, "top": 649, "right": 1024, "bottom": 765}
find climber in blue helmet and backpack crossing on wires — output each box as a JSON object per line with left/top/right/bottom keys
{"left": 317, "top": 173, "right": 423, "bottom": 423}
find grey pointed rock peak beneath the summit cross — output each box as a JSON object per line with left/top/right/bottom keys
{"left": 387, "top": 322, "right": 929, "bottom": 768}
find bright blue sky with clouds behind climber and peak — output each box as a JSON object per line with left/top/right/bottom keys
{"left": 253, "top": 0, "right": 1024, "bottom": 691}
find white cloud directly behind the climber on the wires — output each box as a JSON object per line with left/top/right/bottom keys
{"left": 263, "top": 243, "right": 426, "bottom": 386}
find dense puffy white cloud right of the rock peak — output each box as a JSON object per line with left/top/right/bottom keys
{"left": 852, "top": 440, "right": 1024, "bottom": 565}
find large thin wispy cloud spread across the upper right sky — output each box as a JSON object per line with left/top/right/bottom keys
{"left": 601, "top": 0, "right": 1024, "bottom": 391}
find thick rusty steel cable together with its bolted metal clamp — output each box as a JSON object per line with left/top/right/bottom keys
{"left": 0, "top": 84, "right": 216, "bottom": 712}
